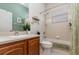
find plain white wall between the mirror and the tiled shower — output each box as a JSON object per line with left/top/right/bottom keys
{"left": 29, "top": 3, "right": 45, "bottom": 34}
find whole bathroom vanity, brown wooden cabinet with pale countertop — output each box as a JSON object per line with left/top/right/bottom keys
{"left": 0, "top": 35, "right": 40, "bottom": 55}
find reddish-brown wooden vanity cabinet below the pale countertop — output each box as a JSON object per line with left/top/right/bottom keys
{"left": 0, "top": 38, "right": 39, "bottom": 55}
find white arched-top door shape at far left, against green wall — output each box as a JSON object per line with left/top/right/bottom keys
{"left": 0, "top": 9, "right": 12, "bottom": 32}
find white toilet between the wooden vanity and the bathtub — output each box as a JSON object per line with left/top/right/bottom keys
{"left": 39, "top": 34, "right": 53, "bottom": 54}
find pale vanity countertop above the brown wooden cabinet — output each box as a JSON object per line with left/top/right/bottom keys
{"left": 0, "top": 34, "right": 39, "bottom": 44}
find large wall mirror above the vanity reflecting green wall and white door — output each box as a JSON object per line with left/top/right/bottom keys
{"left": 0, "top": 3, "right": 29, "bottom": 32}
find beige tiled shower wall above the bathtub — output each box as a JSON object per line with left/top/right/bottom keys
{"left": 45, "top": 4, "right": 72, "bottom": 41}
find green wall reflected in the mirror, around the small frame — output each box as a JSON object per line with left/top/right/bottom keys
{"left": 0, "top": 3, "right": 29, "bottom": 31}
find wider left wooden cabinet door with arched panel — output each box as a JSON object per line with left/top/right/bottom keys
{"left": 0, "top": 42, "right": 24, "bottom": 55}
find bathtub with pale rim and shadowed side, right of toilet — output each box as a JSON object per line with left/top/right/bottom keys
{"left": 46, "top": 38, "right": 72, "bottom": 52}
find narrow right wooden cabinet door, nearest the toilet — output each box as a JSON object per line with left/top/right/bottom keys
{"left": 28, "top": 38, "right": 39, "bottom": 55}
